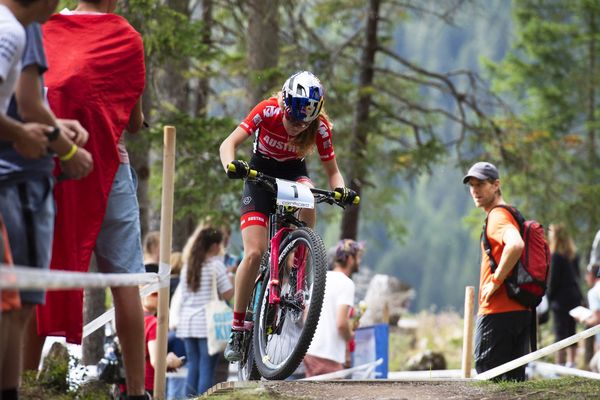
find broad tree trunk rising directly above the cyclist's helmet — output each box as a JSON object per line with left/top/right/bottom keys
{"left": 247, "top": 0, "right": 279, "bottom": 109}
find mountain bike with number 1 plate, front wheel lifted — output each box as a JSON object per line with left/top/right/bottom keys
{"left": 227, "top": 164, "right": 360, "bottom": 380}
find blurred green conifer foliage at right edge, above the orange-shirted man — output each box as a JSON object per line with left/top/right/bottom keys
{"left": 485, "top": 0, "right": 600, "bottom": 248}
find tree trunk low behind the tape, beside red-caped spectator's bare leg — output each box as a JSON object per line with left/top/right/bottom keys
{"left": 81, "top": 256, "right": 106, "bottom": 365}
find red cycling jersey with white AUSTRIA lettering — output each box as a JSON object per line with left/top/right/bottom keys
{"left": 240, "top": 97, "right": 335, "bottom": 161}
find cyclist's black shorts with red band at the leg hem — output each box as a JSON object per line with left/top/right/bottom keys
{"left": 240, "top": 154, "right": 310, "bottom": 229}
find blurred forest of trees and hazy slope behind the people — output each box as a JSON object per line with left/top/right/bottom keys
{"left": 76, "top": 0, "right": 600, "bottom": 318}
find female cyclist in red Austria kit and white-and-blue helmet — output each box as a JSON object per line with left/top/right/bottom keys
{"left": 219, "top": 71, "right": 356, "bottom": 362}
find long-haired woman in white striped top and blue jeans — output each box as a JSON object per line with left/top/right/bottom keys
{"left": 177, "top": 227, "right": 233, "bottom": 396}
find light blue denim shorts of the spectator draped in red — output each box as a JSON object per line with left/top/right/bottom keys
{"left": 94, "top": 164, "right": 145, "bottom": 273}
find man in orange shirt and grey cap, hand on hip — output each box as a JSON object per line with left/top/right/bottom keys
{"left": 463, "top": 162, "right": 531, "bottom": 381}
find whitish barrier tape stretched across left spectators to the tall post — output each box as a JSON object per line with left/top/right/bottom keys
{"left": 0, "top": 264, "right": 161, "bottom": 290}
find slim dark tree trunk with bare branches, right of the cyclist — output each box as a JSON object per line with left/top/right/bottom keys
{"left": 341, "top": 0, "right": 380, "bottom": 239}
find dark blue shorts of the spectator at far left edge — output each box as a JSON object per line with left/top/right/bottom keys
{"left": 0, "top": 176, "right": 56, "bottom": 304}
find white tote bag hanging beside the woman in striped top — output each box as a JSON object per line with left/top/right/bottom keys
{"left": 204, "top": 271, "right": 233, "bottom": 356}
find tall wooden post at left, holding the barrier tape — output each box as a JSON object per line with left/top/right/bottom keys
{"left": 154, "top": 126, "right": 175, "bottom": 400}
